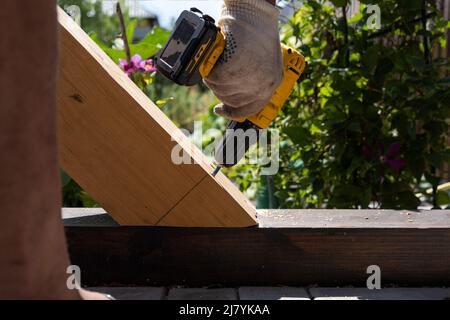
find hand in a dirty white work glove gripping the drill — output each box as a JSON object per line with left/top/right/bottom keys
{"left": 205, "top": 0, "right": 283, "bottom": 119}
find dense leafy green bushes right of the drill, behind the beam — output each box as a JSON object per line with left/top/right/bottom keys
{"left": 268, "top": 0, "right": 450, "bottom": 209}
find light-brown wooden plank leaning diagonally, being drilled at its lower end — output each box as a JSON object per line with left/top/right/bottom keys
{"left": 58, "top": 9, "right": 256, "bottom": 227}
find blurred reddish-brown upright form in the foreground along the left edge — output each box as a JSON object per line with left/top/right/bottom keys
{"left": 0, "top": 0, "right": 79, "bottom": 299}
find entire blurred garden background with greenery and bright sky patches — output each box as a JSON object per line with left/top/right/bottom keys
{"left": 58, "top": 0, "right": 450, "bottom": 209}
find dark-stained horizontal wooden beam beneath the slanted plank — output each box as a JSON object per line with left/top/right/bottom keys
{"left": 64, "top": 209, "right": 450, "bottom": 286}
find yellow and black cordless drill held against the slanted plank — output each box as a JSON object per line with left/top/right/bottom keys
{"left": 155, "top": 8, "right": 305, "bottom": 176}
